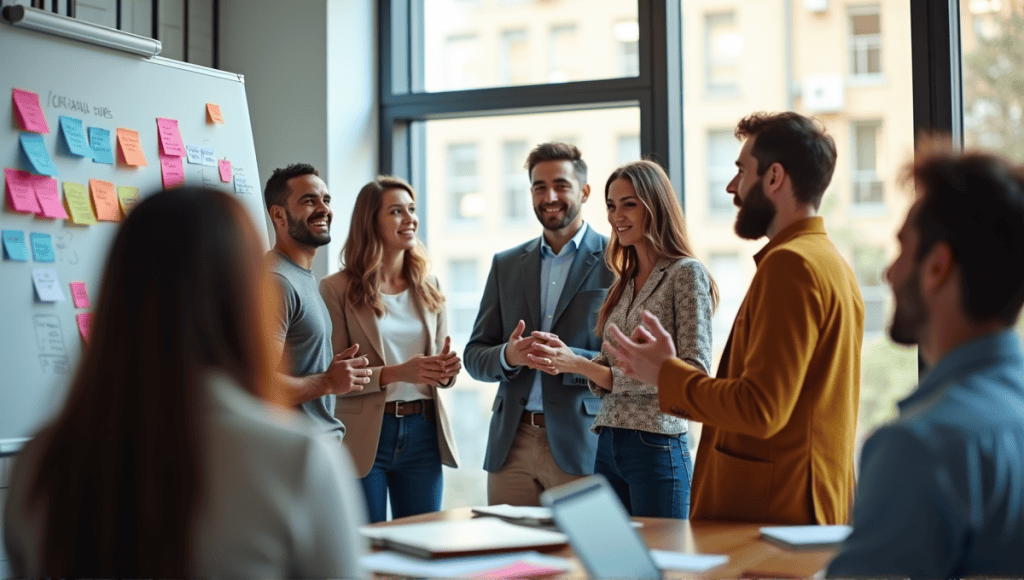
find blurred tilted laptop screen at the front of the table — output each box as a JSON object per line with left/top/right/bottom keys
{"left": 541, "top": 474, "right": 663, "bottom": 580}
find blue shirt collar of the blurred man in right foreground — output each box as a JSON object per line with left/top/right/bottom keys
{"left": 896, "top": 329, "right": 1024, "bottom": 415}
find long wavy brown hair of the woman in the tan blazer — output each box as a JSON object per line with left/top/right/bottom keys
{"left": 341, "top": 175, "right": 444, "bottom": 318}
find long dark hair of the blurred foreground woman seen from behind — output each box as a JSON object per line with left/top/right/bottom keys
{"left": 23, "top": 188, "right": 275, "bottom": 578}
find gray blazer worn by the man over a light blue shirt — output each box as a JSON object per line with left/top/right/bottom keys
{"left": 463, "top": 226, "right": 614, "bottom": 475}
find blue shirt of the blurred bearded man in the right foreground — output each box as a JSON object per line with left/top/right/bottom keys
{"left": 828, "top": 331, "right": 1024, "bottom": 578}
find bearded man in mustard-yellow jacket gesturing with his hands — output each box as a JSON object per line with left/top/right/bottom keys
{"left": 609, "top": 113, "right": 864, "bottom": 524}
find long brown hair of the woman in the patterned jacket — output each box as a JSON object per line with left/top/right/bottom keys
{"left": 594, "top": 160, "right": 718, "bottom": 336}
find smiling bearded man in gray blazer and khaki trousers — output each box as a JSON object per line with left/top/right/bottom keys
{"left": 464, "top": 142, "right": 613, "bottom": 505}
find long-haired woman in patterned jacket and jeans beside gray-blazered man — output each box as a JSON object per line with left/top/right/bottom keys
{"left": 529, "top": 161, "right": 718, "bottom": 519}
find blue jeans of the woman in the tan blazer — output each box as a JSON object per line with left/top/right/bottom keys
{"left": 361, "top": 413, "right": 441, "bottom": 524}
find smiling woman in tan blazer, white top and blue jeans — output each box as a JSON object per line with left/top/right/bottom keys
{"left": 321, "top": 176, "right": 462, "bottom": 522}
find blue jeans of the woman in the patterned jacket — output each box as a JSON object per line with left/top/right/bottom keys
{"left": 594, "top": 427, "right": 693, "bottom": 520}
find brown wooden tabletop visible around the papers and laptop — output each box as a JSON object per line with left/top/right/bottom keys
{"left": 374, "top": 507, "right": 836, "bottom": 578}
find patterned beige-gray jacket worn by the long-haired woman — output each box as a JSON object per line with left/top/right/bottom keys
{"left": 590, "top": 258, "right": 712, "bottom": 434}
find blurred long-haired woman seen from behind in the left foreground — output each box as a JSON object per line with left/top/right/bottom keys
{"left": 4, "top": 188, "right": 364, "bottom": 578}
